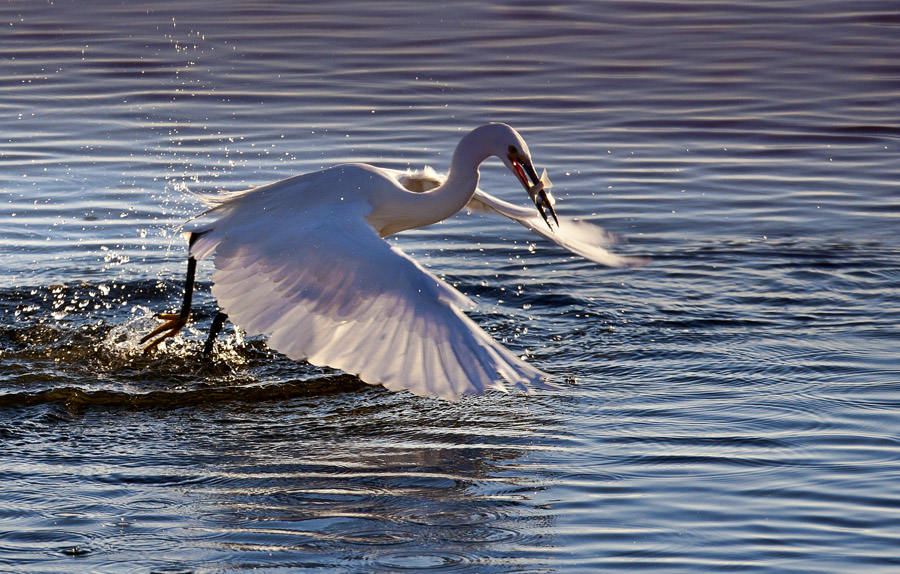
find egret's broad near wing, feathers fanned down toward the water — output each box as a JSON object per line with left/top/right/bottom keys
{"left": 192, "top": 202, "right": 548, "bottom": 399}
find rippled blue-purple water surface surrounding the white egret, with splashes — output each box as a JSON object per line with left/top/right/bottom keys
{"left": 0, "top": 0, "right": 900, "bottom": 574}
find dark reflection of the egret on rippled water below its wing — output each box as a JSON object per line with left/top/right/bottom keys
{"left": 197, "top": 410, "right": 552, "bottom": 572}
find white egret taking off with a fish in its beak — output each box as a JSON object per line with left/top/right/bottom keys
{"left": 142, "top": 123, "right": 642, "bottom": 400}
